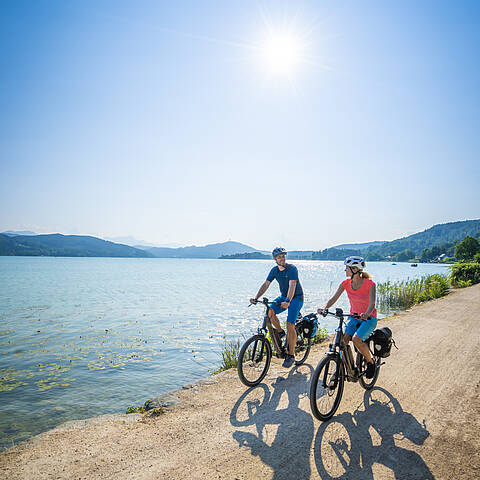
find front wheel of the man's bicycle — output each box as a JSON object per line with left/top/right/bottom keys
{"left": 237, "top": 335, "right": 272, "bottom": 387}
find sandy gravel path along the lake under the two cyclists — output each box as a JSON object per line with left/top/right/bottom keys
{"left": 0, "top": 285, "right": 480, "bottom": 480}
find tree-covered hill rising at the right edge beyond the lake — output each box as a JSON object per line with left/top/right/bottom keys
{"left": 365, "top": 220, "right": 480, "bottom": 257}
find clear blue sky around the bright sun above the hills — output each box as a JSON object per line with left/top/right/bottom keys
{"left": 0, "top": 0, "right": 480, "bottom": 249}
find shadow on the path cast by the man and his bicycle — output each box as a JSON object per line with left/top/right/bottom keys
{"left": 230, "top": 364, "right": 314, "bottom": 480}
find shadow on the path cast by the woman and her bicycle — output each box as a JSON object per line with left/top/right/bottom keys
{"left": 314, "top": 387, "right": 434, "bottom": 480}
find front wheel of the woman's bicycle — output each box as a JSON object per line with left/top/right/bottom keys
{"left": 310, "top": 355, "right": 345, "bottom": 422}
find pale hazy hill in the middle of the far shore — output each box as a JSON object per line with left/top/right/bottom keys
{"left": 145, "top": 242, "right": 264, "bottom": 258}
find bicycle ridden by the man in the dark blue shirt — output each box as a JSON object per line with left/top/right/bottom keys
{"left": 237, "top": 297, "right": 315, "bottom": 387}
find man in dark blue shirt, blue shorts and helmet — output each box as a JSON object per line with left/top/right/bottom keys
{"left": 250, "top": 247, "right": 303, "bottom": 368}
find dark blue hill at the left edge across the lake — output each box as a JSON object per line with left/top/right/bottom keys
{"left": 0, "top": 233, "right": 153, "bottom": 258}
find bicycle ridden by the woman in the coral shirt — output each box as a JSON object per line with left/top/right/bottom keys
{"left": 310, "top": 308, "right": 384, "bottom": 422}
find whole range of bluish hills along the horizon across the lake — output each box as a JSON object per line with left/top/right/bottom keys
{"left": 0, "top": 220, "right": 480, "bottom": 260}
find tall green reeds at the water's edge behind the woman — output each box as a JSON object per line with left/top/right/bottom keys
{"left": 377, "top": 274, "right": 450, "bottom": 313}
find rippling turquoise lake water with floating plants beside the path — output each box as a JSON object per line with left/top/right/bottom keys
{"left": 0, "top": 257, "right": 447, "bottom": 448}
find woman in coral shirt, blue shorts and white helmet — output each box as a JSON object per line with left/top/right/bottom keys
{"left": 318, "top": 256, "right": 377, "bottom": 378}
